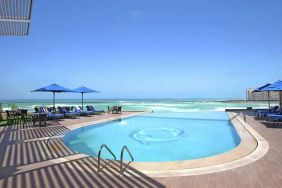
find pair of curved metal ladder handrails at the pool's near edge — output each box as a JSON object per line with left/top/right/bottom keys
{"left": 97, "top": 144, "right": 134, "bottom": 175}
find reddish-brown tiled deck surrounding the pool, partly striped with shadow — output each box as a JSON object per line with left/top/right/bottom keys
{"left": 0, "top": 112, "right": 282, "bottom": 188}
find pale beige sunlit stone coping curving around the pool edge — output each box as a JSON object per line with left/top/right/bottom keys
{"left": 57, "top": 112, "right": 269, "bottom": 177}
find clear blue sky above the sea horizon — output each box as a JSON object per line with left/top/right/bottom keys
{"left": 0, "top": 0, "right": 282, "bottom": 99}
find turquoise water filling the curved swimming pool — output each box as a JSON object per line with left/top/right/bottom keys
{"left": 64, "top": 112, "right": 240, "bottom": 162}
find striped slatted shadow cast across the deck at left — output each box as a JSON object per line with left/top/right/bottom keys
{"left": 0, "top": 121, "right": 164, "bottom": 188}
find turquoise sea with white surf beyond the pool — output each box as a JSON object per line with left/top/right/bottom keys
{"left": 0, "top": 99, "right": 278, "bottom": 112}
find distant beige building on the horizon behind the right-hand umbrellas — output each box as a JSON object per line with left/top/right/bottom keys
{"left": 246, "top": 88, "right": 279, "bottom": 101}
